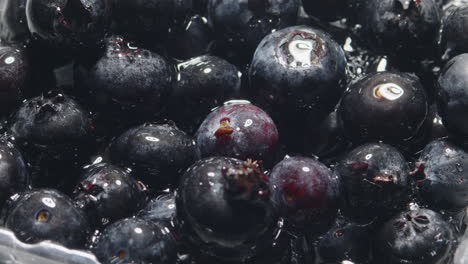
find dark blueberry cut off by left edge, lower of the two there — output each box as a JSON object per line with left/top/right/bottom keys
{"left": 0, "top": 141, "right": 31, "bottom": 205}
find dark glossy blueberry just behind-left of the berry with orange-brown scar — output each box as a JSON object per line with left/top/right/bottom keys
{"left": 168, "top": 55, "right": 241, "bottom": 132}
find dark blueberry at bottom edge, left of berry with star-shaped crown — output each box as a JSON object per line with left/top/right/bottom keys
{"left": 317, "top": 217, "right": 372, "bottom": 263}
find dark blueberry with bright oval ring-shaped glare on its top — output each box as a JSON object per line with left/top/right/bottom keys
{"left": 339, "top": 72, "right": 429, "bottom": 144}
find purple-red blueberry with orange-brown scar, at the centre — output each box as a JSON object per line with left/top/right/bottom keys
{"left": 195, "top": 101, "right": 278, "bottom": 165}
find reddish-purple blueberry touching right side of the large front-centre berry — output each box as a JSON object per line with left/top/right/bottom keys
{"left": 270, "top": 157, "right": 341, "bottom": 234}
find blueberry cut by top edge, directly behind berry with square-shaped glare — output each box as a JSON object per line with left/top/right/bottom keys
{"left": 207, "top": 0, "right": 299, "bottom": 54}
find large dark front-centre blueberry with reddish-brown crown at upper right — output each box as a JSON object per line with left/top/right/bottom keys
{"left": 176, "top": 157, "right": 277, "bottom": 261}
